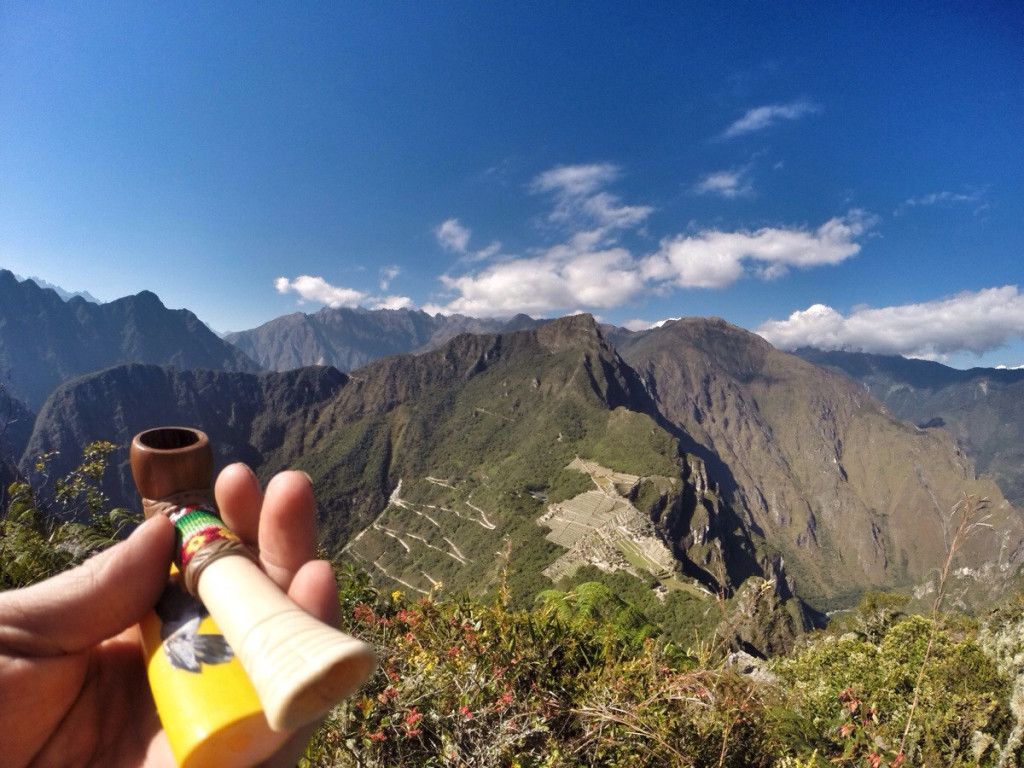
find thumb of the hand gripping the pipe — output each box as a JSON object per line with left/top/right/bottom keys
{"left": 0, "top": 515, "right": 174, "bottom": 655}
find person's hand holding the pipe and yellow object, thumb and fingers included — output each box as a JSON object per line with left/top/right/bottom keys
{"left": 0, "top": 464, "right": 338, "bottom": 768}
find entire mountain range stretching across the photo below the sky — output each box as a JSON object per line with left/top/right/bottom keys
{"left": 0, "top": 272, "right": 1024, "bottom": 653}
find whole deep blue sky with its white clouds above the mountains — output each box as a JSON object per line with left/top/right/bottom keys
{"left": 0, "top": 0, "right": 1024, "bottom": 366}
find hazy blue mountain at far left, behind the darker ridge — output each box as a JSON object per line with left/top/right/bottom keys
{"left": 0, "top": 269, "right": 260, "bottom": 411}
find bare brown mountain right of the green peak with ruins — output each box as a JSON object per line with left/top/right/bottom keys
{"left": 623, "top": 318, "right": 1024, "bottom": 607}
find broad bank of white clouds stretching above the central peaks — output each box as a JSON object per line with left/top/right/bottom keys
{"left": 286, "top": 164, "right": 874, "bottom": 316}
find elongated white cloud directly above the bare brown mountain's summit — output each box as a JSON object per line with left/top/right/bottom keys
{"left": 642, "top": 210, "right": 874, "bottom": 288}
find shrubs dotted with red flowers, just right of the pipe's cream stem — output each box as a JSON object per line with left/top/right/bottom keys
{"left": 305, "top": 578, "right": 780, "bottom": 767}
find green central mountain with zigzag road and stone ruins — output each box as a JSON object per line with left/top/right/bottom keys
{"left": 290, "top": 316, "right": 806, "bottom": 650}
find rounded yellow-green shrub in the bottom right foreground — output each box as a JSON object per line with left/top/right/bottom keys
{"left": 776, "top": 616, "right": 1011, "bottom": 766}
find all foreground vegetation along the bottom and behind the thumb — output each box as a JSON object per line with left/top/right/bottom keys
{"left": 6, "top": 443, "right": 1024, "bottom": 768}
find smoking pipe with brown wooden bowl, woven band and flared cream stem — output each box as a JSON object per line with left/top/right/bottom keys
{"left": 130, "top": 427, "right": 376, "bottom": 731}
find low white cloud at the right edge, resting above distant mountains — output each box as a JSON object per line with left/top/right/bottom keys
{"left": 758, "top": 286, "right": 1024, "bottom": 358}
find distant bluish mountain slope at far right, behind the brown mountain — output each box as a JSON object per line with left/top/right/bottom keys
{"left": 796, "top": 349, "right": 1024, "bottom": 509}
